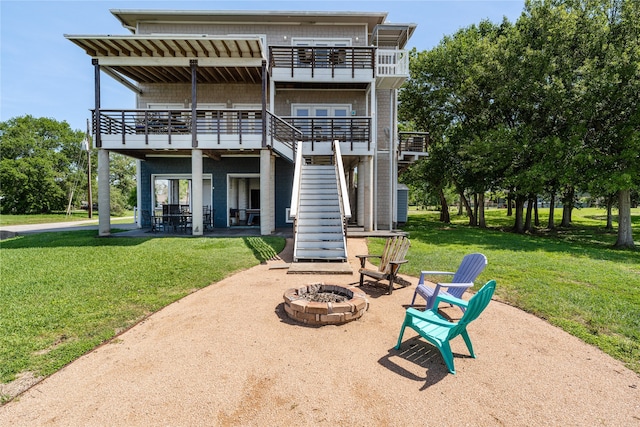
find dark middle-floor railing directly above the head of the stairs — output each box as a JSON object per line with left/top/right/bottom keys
{"left": 282, "top": 117, "right": 371, "bottom": 151}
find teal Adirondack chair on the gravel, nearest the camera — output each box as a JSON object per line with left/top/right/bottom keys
{"left": 396, "top": 280, "right": 496, "bottom": 374}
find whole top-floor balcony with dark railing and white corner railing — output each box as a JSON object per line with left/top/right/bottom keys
{"left": 269, "top": 46, "right": 409, "bottom": 89}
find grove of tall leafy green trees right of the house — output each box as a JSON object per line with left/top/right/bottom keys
{"left": 399, "top": 0, "right": 640, "bottom": 247}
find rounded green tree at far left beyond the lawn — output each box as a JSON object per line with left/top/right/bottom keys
{"left": 0, "top": 115, "right": 86, "bottom": 214}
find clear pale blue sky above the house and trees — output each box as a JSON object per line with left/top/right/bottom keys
{"left": 0, "top": 0, "right": 524, "bottom": 130}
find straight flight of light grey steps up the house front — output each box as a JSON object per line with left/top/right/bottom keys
{"left": 293, "top": 164, "right": 347, "bottom": 262}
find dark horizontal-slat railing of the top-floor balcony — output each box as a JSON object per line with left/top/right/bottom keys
{"left": 269, "top": 46, "right": 376, "bottom": 78}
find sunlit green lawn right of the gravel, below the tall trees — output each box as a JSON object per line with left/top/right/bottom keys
{"left": 369, "top": 209, "right": 640, "bottom": 373}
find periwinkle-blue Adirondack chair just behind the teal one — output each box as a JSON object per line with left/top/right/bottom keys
{"left": 411, "top": 253, "right": 487, "bottom": 312}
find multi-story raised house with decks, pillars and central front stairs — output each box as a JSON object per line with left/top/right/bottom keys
{"left": 65, "top": 10, "right": 426, "bottom": 259}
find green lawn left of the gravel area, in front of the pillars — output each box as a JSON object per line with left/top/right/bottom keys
{"left": 0, "top": 231, "right": 285, "bottom": 382}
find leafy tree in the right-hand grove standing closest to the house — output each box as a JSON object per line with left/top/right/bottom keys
{"left": 399, "top": 21, "right": 510, "bottom": 226}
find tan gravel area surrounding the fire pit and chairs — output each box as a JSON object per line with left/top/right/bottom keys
{"left": 0, "top": 239, "right": 640, "bottom": 426}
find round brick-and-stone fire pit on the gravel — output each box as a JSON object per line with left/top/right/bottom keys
{"left": 284, "top": 283, "right": 369, "bottom": 325}
